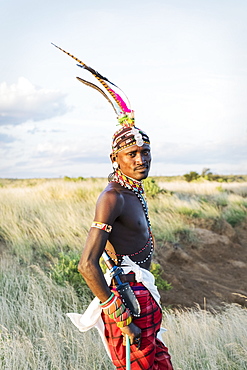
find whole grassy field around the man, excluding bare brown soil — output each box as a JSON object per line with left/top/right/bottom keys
{"left": 0, "top": 178, "right": 247, "bottom": 370}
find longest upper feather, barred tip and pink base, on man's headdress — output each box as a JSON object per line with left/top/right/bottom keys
{"left": 52, "top": 43, "right": 132, "bottom": 114}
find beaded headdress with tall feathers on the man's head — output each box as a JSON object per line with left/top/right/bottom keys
{"left": 52, "top": 43, "right": 150, "bottom": 154}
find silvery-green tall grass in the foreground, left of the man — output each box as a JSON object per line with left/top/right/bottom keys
{"left": 0, "top": 257, "right": 112, "bottom": 370}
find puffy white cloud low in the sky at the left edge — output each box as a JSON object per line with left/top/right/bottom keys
{"left": 0, "top": 77, "right": 70, "bottom": 126}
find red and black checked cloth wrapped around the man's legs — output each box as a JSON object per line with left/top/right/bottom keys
{"left": 102, "top": 283, "right": 173, "bottom": 370}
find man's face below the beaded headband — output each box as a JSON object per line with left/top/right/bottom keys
{"left": 116, "top": 144, "right": 151, "bottom": 181}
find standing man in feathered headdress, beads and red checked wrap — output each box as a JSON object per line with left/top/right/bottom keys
{"left": 53, "top": 44, "right": 173, "bottom": 370}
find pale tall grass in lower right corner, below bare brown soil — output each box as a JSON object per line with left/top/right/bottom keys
{"left": 164, "top": 305, "right": 247, "bottom": 370}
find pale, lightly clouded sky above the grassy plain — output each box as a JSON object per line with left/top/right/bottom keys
{"left": 0, "top": 0, "right": 247, "bottom": 178}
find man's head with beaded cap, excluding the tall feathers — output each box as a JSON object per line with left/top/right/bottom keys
{"left": 110, "top": 127, "right": 151, "bottom": 181}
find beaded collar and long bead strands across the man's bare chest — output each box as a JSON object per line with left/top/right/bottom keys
{"left": 108, "top": 169, "right": 154, "bottom": 265}
